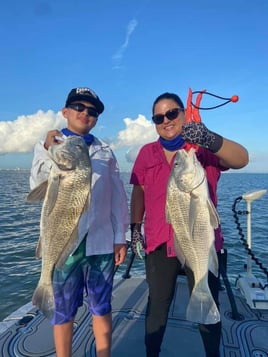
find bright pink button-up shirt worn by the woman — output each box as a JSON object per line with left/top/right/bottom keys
{"left": 130, "top": 140, "right": 228, "bottom": 256}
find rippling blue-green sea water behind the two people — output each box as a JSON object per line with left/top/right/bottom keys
{"left": 0, "top": 170, "right": 268, "bottom": 321}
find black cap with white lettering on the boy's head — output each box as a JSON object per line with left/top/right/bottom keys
{"left": 65, "top": 87, "right": 104, "bottom": 114}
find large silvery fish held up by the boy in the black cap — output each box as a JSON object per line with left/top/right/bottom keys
{"left": 26, "top": 136, "right": 92, "bottom": 319}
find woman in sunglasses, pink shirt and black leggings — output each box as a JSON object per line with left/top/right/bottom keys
{"left": 130, "top": 93, "right": 248, "bottom": 357}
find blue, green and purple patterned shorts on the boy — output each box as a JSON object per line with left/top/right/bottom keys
{"left": 51, "top": 239, "right": 114, "bottom": 325}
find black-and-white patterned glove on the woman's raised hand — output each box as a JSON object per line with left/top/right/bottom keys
{"left": 181, "top": 122, "right": 223, "bottom": 153}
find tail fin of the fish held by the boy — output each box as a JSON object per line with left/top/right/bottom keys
{"left": 32, "top": 284, "right": 55, "bottom": 320}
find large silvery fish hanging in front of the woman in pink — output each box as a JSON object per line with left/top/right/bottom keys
{"left": 165, "top": 148, "right": 220, "bottom": 324}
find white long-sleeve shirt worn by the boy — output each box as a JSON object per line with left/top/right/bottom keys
{"left": 30, "top": 136, "right": 129, "bottom": 256}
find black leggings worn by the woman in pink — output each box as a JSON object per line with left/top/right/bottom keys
{"left": 145, "top": 244, "right": 221, "bottom": 357}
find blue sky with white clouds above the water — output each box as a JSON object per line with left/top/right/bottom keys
{"left": 0, "top": 0, "right": 268, "bottom": 173}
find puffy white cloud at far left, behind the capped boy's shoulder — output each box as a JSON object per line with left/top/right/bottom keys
{"left": 0, "top": 110, "right": 66, "bottom": 154}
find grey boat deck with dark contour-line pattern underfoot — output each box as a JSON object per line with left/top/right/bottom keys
{"left": 0, "top": 276, "right": 268, "bottom": 357}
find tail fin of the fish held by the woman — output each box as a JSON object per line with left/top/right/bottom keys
{"left": 186, "top": 288, "right": 220, "bottom": 325}
